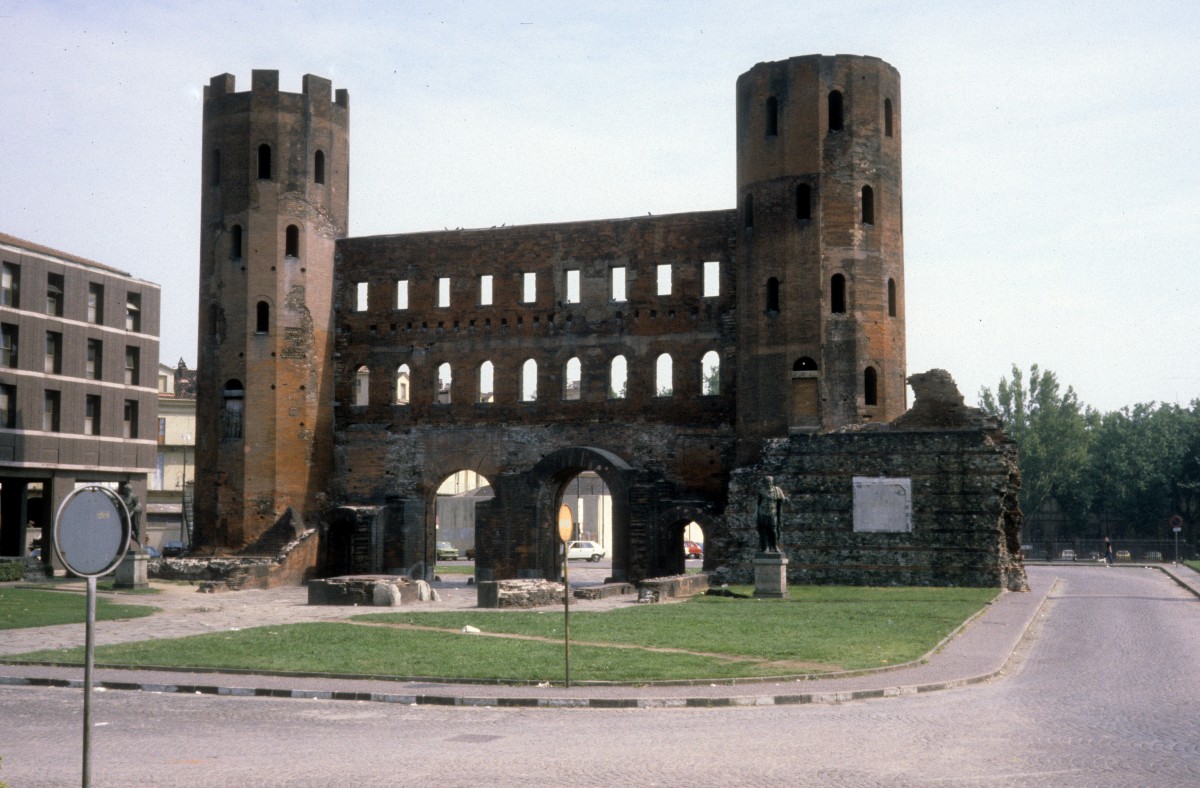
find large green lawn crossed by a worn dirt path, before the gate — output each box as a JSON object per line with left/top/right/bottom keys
{"left": 2, "top": 587, "right": 997, "bottom": 681}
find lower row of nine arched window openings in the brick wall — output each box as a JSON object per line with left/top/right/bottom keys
{"left": 352, "top": 350, "right": 721, "bottom": 405}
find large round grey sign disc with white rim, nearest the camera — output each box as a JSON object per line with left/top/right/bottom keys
{"left": 54, "top": 486, "right": 130, "bottom": 577}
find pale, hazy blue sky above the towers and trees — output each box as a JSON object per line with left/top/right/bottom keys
{"left": 0, "top": 0, "right": 1200, "bottom": 410}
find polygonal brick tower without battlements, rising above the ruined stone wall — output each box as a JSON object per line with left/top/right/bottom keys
{"left": 737, "top": 55, "right": 906, "bottom": 462}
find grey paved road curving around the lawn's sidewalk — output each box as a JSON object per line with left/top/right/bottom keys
{"left": 0, "top": 566, "right": 1200, "bottom": 788}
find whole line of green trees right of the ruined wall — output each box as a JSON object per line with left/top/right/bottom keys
{"left": 979, "top": 365, "right": 1200, "bottom": 553}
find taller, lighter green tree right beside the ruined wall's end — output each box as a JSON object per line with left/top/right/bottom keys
{"left": 979, "top": 365, "right": 1099, "bottom": 536}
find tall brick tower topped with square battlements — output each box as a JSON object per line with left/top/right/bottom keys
{"left": 192, "top": 71, "right": 349, "bottom": 553}
